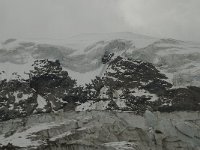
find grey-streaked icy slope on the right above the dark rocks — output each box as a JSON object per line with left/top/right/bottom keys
{"left": 130, "top": 39, "right": 200, "bottom": 87}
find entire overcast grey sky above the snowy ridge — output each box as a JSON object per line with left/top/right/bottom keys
{"left": 0, "top": 0, "right": 200, "bottom": 41}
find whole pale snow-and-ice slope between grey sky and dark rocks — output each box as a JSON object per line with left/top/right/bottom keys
{"left": 0, "top": 33, "right": 200, "bottom": 87}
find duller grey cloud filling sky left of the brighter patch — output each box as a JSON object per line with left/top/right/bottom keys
{"left": 0, "top": 0, "right": 128, "bottom": 38}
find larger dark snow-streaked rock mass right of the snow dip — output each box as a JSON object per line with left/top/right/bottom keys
{"left": 83, "top": 56, "right": 200, "bottom": 114}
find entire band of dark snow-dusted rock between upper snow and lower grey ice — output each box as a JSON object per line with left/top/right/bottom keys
{"left": 0, "top": 56, "right": 200, "bottom": 121}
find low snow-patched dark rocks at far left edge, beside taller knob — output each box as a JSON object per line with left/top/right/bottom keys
{"left": 0, "top": 80, "right": 37, "bottom": 121}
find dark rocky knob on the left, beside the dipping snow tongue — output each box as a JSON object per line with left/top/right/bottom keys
{"left": 29, "top": 60, "right": 78, "bottom": 110}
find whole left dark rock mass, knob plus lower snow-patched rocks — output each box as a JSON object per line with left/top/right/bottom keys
{"left": 0, "top": 60, "right": 85, "bottom": 121}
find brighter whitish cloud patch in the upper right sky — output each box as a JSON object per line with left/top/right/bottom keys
{"left": 120, "top": 0, "right": 200, "bottom": 40}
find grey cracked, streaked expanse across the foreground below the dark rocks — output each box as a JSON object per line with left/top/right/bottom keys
{"left": 0, "top": 111, "right": 200, "bottom": 150}
